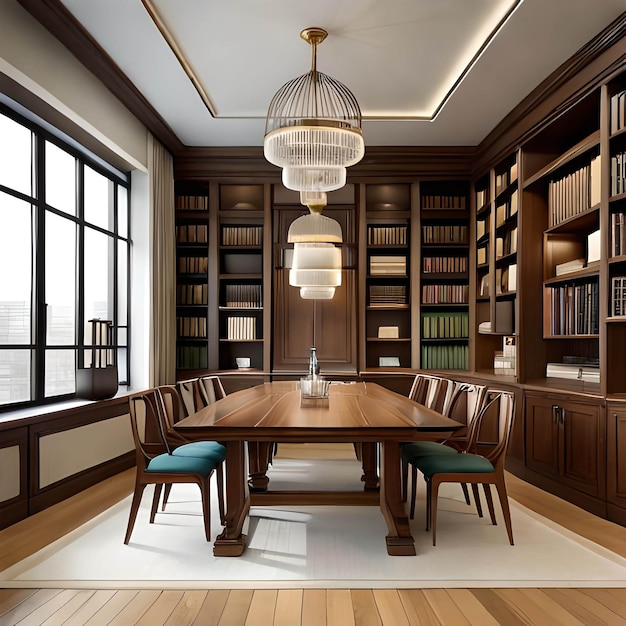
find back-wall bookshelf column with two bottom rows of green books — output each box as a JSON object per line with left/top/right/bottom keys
{"left": 419, "top": 181, "right": 469, "bottom": 370}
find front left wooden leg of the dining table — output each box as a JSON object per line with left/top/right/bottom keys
{"left": 213, "top": 441, "right": 250, "bottom": 556}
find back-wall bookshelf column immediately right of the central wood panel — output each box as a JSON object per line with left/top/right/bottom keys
{"left": 364, "top": 183, "right": 413, "bottom": 369}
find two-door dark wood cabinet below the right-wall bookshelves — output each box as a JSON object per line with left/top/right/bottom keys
{"left": 525, "top": 392, "right": 606, "bottom": 511}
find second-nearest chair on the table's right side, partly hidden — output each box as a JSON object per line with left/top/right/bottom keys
{"left": 401, "top": 382, "right": 487, "bottom": 519}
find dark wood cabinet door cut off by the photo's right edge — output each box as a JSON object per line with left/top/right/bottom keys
{"left": 606, "top": 402, "right": 626, "bottom": 525}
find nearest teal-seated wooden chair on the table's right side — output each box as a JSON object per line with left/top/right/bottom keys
{"left": 412, "top": 390, "right": 515, "bottom": 545}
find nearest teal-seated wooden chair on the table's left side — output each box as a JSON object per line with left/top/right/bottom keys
{"left": 124, "top": 391, "right": 218, "bottom": 544}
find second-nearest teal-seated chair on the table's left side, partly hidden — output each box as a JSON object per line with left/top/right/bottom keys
{"left": 155, "top": 385, "right": 226, "bottom": 522}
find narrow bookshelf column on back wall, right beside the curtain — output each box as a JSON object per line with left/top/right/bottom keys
{"left": 175, "top": 185, "right": 209, "bottom": 370}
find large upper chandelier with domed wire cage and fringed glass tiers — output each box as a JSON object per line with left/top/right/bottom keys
{"left": 263, "top": 28, "right": 365, "bottom": 192}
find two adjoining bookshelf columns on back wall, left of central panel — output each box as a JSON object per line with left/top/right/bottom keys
{"left": 176, "top": 182, "right": 271, "bottom": 378}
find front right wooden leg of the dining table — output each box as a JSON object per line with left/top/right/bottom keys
{"left": 380, "top": 441, "right": 415, "bottom": 556}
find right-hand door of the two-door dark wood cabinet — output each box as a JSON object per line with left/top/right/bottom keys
{"left": 559, "top": 402, "right": 604, "bottom": 496}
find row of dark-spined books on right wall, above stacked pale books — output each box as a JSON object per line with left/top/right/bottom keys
{"left": 547, "top": 280, "right": 599, "bottom": 335}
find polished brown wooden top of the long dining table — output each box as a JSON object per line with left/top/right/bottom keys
{"left": 175, "top": 381, "right": 462, "bottom": 442}
